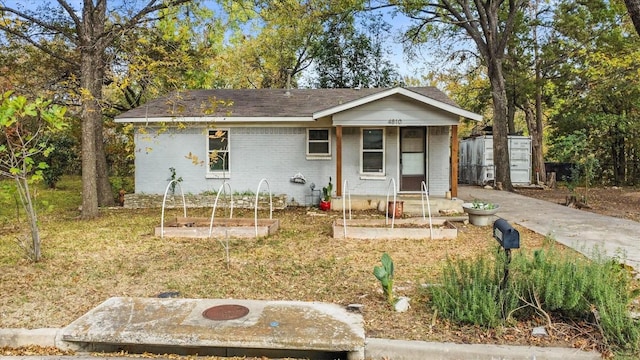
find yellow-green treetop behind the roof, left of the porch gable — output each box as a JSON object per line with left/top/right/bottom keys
{"left": 215, "top": 0, "right": 328, "bottom": 88}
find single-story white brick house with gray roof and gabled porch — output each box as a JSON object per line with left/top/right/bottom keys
{"left": 116, "top": 87, "right": 482, "bottom": 204}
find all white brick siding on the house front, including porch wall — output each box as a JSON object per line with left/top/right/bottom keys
{"left": 135, "top": 123, "right": 450, "bottom": 204}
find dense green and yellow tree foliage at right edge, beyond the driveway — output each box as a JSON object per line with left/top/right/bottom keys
{"left": 544, "top": 0, "right": 640, "bottom": 184}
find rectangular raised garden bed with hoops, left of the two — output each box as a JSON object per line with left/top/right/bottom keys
{"left": 155, "top": 217, "right": 280, "bottom": 238}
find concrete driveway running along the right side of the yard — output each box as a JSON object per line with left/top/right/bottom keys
{"left": 458, "top": 186, "right": 640, "bottom": 271}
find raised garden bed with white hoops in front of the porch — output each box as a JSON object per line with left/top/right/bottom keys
{"left": 333, "top": 218, "right": 458, "bottom": 240}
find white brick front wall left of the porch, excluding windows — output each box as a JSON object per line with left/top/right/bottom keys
{"left": 135, "top": 127, "right": 336, "bottom": 204}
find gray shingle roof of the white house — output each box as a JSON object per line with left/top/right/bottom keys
{"left": 116, "top": 87, "right": 459, "bottom": 120}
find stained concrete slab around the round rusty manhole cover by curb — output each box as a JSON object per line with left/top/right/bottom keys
{"left": 62, "top": 297, "right": 365, "bottom": 360}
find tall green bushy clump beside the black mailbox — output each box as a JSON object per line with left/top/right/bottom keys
{"left": 430, "top": 246, "right": 640, "bottom": 354}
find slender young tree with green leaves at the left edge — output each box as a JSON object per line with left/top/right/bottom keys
{"left": 0, "top": 92, "right": 66, "bottom": 261}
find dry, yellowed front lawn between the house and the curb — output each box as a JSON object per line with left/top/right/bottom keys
{"left": 0, "top": 201, "right": 594, "bottom": 348}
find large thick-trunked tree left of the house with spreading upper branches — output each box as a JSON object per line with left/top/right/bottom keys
{"left": 0, "top": 0, "right": 191, "bottom": 218}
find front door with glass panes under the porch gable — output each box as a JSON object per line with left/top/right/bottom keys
{"left": 400, "top": 127, "right": 426, "bottom": 191}
